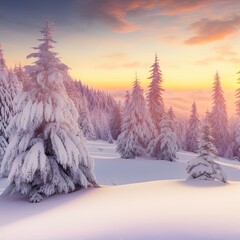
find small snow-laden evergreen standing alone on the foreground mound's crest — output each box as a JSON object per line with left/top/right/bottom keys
{"left": 187, "top": 112, "right": 227, "bottom": 182}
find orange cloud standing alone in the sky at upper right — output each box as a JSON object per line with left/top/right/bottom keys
{"left": 185, "top": 15, "right": 240, "bottom": 45}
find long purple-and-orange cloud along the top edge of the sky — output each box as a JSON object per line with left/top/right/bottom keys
{"left": 78, "top": 0, "right": 232, "bottom": 32}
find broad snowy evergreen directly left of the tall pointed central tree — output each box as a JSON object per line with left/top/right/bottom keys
{"left": 117, "top": 78, "right": 155, "bottom": 158}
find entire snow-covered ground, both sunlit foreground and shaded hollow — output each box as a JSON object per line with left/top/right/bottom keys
{"left": 0, "top": 141, "right": 240, "bottom": 240}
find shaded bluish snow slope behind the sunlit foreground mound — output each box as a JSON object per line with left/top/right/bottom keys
{"left": 88, "top": 141, "right": 240, "bottom": 185}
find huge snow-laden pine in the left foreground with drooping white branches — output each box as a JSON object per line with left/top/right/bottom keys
{"left": 0, "top": 21, "right": 97, "bottom": 202}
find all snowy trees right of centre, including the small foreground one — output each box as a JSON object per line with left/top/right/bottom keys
{"left": 117, "top": 56, "right": 240, "bottom": 182}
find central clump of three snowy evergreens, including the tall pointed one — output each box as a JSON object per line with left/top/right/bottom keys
{"left": 117, "top": 55, "right": 179, "bottom": 161}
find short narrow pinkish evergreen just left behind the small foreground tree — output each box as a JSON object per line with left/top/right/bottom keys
{"left": 186, "top": 102, "right": 200, "bottom": 152}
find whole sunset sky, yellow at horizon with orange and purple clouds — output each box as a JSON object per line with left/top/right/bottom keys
{"left": 0, "top": 0, "right": 240, "bottom": 112}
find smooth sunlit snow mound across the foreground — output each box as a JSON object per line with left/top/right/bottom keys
{"left": 0, "top": 180, "right": 240, "bottom": 240}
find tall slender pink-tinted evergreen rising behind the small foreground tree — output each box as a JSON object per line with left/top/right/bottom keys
{"left": 211, "top": 73, "right": 229, "bottom": 156}
